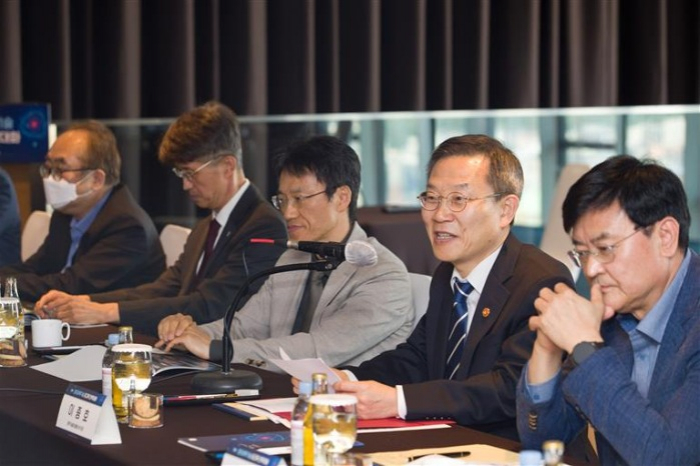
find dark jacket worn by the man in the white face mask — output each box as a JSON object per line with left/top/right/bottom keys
{"left": 0, "top": 184, "right": 165, "bottom": 301}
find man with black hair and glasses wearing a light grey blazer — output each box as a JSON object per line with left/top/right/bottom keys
{"left": 157, "top": 136, "right": 414, "bottom": 370}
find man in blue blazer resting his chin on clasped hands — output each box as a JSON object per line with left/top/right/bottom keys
{"left": 518, "top": 155, "right": 700, "bottom": 465}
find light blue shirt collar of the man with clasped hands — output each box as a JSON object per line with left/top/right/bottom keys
{"left": 618, "top": 251, "right": 690, "bottom": 343}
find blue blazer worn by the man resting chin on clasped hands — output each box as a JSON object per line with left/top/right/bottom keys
{"left": 518, "top": 252, "right": 700, "bottom": 465}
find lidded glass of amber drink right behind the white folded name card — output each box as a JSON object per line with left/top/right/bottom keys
{"left": 112, "top": 343, "right": 153, "bottom": 424}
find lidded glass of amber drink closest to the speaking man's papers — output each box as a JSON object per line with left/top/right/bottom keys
{"left": 309, "top": 393, "right": 357, "bottom": 464}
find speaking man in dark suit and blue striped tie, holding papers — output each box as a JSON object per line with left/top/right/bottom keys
{"left": 334, "top": 135, "right": 573, "bottom": 439}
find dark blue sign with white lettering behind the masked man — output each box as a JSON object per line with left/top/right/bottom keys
{"left": 0, "top": 104, "right": 51, "bottom": 163}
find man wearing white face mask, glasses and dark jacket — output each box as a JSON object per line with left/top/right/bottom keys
{"left": 0, "top": 121, "right": 165, "bottom": 302}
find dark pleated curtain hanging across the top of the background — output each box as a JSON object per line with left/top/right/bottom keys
{"left": 0, "top": 0, "right": 700, "bottom": 120}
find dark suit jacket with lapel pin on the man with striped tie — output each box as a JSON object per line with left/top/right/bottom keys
{"left": 350, "top": 233, "right": 573, "bottom": 439}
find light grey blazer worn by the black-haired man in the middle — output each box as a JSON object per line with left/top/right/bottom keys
{"left": 202, "top": 224, "right": 414, "bottom": 370}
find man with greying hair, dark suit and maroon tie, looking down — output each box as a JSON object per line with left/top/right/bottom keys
{"left": 36, "top": 102, "right": 286, "bottom": 334}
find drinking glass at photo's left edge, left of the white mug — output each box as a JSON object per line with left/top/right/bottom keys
{"left": 0, "top": 298, "right": 27, "bottom": 367}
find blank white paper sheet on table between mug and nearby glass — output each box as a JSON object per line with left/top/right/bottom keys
{"left": 32, "top": 345, "right": 107, "bottom": 382}
